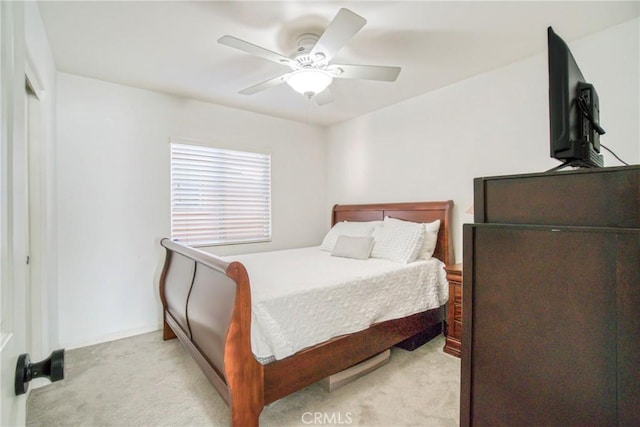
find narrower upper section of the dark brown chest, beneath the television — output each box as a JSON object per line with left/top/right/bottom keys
{"left": 473, "top": 166, "right": 640, "bottom": 228}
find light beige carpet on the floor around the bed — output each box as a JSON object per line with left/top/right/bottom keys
{"left": 27, "top": 332, "right": 460, "bottom": 427}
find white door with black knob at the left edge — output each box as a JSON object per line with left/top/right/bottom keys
{"left": 0, "top": 1, "right": 29, "bottom": 426}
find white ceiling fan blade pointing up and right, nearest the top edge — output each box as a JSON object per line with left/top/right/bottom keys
{"left": 310, "top": 8, "right": 367, "bottom": 61}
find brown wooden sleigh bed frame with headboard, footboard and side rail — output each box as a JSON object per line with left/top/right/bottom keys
{"left": 160, "top": 201, "right": 454, "bottom": 427}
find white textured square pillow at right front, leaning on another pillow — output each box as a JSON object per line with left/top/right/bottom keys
{"left": 371, "top": 223, "right": 424, "bottom": 264}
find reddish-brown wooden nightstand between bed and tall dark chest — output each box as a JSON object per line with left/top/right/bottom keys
{"left": 443, "top": 263, "right": 462, "bottom": 357}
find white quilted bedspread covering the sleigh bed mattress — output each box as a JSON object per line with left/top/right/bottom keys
{"left": 233, "top": 247, "right": 449, "bottom": 361}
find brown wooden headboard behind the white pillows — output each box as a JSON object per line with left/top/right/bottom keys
{"left": 331, "top": 200, "right": 455, "bottom": 265}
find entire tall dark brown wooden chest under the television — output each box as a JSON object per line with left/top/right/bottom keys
{"left": 460, "top": 166, "right": 640, "bottom": 426}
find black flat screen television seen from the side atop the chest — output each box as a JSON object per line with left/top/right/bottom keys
{"left": 547, "top": 27, "right": 604, "bottom": 170}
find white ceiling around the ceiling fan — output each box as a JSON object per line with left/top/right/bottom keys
{"left": 38, "top": 1, "right": 640, "bottom": 126}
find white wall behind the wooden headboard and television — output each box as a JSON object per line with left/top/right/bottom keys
{"left": 327, "top": 19, "right": 640, "bottom": 261}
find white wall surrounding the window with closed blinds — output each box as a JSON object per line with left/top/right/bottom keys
{"left": 57, "top": 73, "right": 330, "bottom": 348}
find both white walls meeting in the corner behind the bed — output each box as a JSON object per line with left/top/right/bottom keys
{"left": 56, "top": 19, "right": 640, "bottom": 348}
